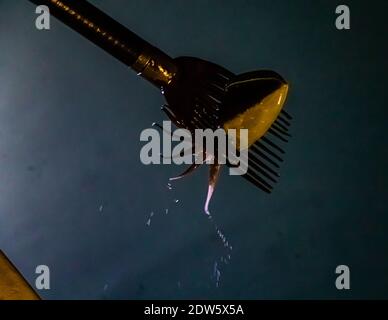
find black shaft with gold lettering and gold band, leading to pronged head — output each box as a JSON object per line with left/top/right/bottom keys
{"left": 29, "top": 0, "right": 177, "bottom": 88}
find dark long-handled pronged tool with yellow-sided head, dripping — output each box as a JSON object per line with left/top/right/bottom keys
{"left": 29, "top": 0, "right": 291, "bottom": 203}
